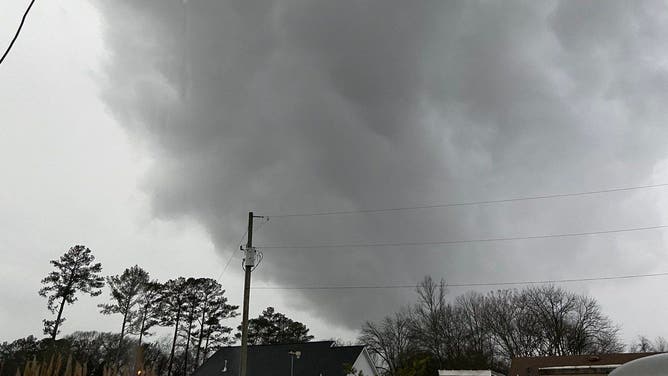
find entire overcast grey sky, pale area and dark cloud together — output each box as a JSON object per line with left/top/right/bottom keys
{"left": 0, "top": 0, "right": 668, "bottom": 342}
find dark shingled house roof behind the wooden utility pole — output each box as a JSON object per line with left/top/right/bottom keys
{"left": 193, "top": 341, "right": 364, "bottom": 376}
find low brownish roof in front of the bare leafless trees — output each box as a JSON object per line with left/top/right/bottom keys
{"left": 508, "top": 353, "right": 656, "bottom": 376}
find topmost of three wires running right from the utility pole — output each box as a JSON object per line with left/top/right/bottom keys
{"left": 267, "top": 183, "right": 668, "bottom": 218}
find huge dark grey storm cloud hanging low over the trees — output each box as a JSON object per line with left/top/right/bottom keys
{"left": 94, "top": 0, "right": 668, "bottom": 328}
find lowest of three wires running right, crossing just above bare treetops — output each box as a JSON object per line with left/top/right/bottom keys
{"left": 253, "top": 272, "right": 668, "bottom": 290}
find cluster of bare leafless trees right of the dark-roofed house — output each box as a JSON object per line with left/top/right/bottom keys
{"left": 360, "top": 277, "right": 628, "bottom": 376}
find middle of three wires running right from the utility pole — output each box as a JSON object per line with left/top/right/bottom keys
{"left": 258, "top": 225, "right": 668, "bottom": 249}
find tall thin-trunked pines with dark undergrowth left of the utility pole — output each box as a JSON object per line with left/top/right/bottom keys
{"left": 0, "top": 245, "right": 238, "bottom": 376}
